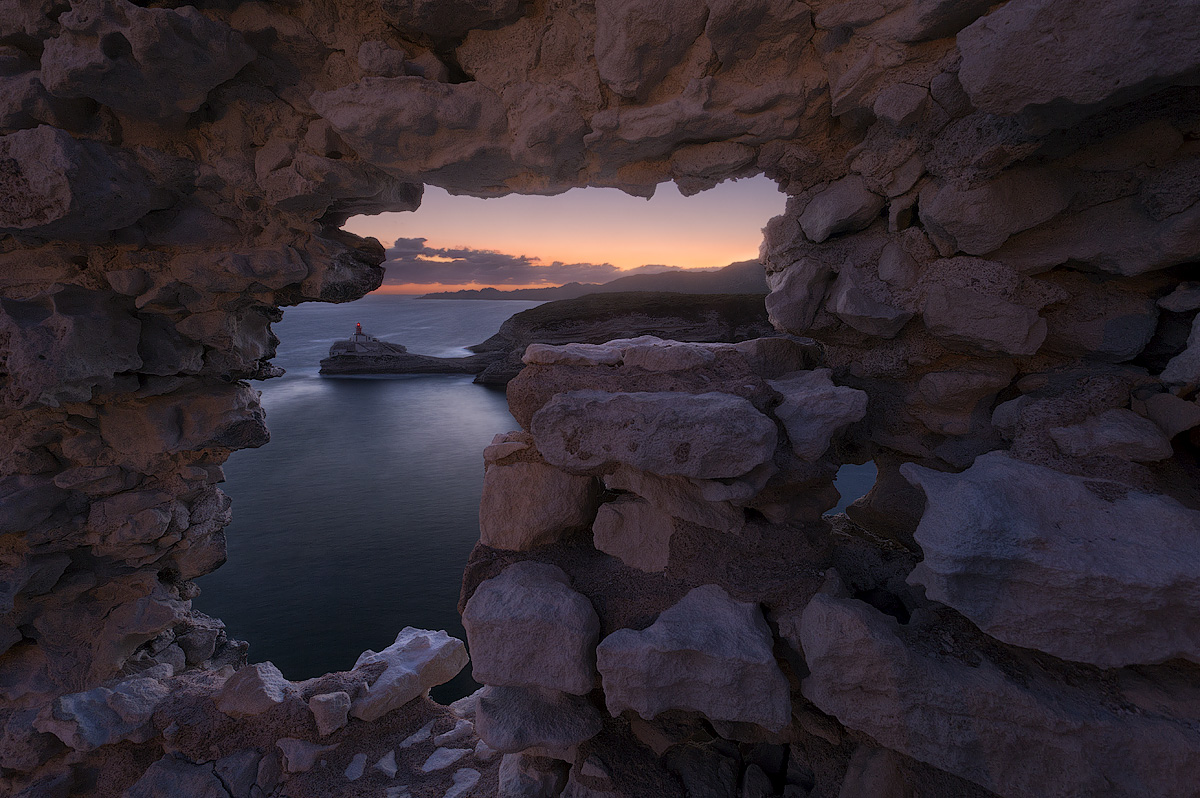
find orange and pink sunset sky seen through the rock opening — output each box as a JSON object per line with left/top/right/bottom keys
{"left": 346, "top": 176, "right": 785, "bottom": 294}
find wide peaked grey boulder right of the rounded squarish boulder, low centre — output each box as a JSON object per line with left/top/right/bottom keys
{"left": 596, "top": 584, "right": 791, "bottom": 732}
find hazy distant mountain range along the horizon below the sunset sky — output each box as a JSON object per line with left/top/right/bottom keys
{"left": 420, "top": 260, "right": 767, "bottom": 301}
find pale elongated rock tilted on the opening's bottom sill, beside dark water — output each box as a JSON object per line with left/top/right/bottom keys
{"left": 350, "top": 626, "right": 467, "bottom": 721}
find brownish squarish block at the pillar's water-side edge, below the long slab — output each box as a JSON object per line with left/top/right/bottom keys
{"left": 479, "top": 462, "right": 596, "bottom": 551}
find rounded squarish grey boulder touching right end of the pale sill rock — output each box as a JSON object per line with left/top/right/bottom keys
{"left": 462, "top": 562, "right": 600, "bottom": 691}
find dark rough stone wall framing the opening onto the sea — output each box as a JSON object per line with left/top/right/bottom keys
{"left": 0, "top": 0, "right": 1200, "bottom": 798}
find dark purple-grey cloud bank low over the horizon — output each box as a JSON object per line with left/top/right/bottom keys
{"left": 384, "top": 239, "right": 679, "bottom": 286}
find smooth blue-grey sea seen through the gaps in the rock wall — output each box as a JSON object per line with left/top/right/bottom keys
{"left": 193, "top": 294, "right": 875, "bottom": 701}
